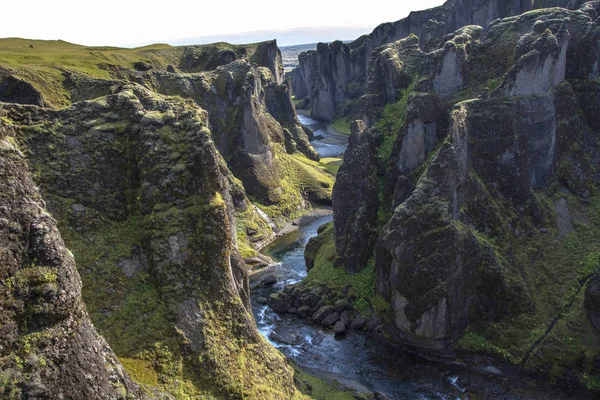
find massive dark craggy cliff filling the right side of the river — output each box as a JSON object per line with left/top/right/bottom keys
{"left": 324, "top": 2, "right": 600, "bottom": 387}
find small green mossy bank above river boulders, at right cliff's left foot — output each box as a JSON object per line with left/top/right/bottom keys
{"left": 303, "top": 222, "right": 390, "bottom": 318}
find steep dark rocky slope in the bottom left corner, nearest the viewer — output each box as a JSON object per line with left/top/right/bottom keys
{"left": 0, "top": 121, "right": 145, "bottom": 399}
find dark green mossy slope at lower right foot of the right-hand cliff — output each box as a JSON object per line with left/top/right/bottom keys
{"left": 459, "top": 193, "right": 600, "bottom": 377}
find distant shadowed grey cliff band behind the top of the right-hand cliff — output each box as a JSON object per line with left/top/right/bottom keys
{"left": 292, "top": 0, "right": 583, "bottom": 121}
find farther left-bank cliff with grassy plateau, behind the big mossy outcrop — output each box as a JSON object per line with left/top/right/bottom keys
{"left": 0, "top": 39, "right": 333, "bottom": 250}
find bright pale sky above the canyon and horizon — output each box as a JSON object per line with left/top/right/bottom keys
{"left": 0, "top": 0, "right": 444, "bottom": 47}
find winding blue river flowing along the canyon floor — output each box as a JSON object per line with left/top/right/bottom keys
{"left": 251, "top": 116, "right": 569, "bottom": 400}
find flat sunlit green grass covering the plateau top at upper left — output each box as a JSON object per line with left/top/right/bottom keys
{"left": 0, "top": 38, "right": 264, "bottom": 108}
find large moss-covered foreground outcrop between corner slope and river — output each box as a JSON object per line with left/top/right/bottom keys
{"left": 3, "top": 84, "right": 294, "bottom": 398}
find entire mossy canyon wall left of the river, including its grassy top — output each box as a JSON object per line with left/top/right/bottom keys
{"left": 0, "top": 37, "right": 324, "bottom": 399}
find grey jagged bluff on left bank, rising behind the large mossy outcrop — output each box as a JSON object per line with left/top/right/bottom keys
{"left": 140, "top": 60, "right": 327, "bottom": 212}
